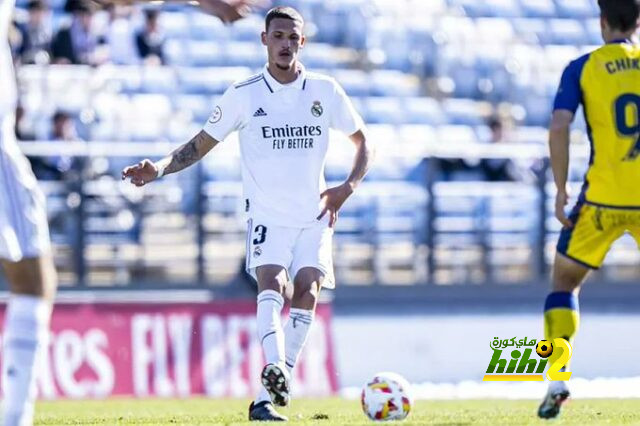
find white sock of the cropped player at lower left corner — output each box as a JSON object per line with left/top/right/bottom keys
{"left": 2, "top": 295, "right": 51, "bottom": 426}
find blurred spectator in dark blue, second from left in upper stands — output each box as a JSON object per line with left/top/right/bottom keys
{"left": 51, "top": 0, "right": 106, "bottom": 65}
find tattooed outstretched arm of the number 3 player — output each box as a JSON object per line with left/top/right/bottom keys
{"left": 122, "top": 130, "right": 218, "bottom": 186}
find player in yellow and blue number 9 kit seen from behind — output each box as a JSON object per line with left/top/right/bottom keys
{"left": 538, "top": 0, "right": 640, "bottom": 418}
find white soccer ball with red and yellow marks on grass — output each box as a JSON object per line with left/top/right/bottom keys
{"left": 361, "top": 373, "right": 413, "bottom": 421}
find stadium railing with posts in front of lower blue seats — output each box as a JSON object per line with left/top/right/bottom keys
{"left": 11, "top": 142, "right": 638, "bottom": 294}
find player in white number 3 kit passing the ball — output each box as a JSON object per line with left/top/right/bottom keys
{"left": 122, "top": 7, "right": 372, "bottom": 421}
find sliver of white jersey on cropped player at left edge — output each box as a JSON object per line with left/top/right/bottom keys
{"left": 0, "top": 0, "right": 17, "bottom": 122}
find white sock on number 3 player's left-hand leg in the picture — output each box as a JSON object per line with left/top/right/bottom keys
{"left": 255, "top": 290, "right": 284, "bottom": 403}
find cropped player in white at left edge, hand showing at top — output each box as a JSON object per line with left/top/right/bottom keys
{"left": 0, "top": 0, "right": 256, "bottom": 426}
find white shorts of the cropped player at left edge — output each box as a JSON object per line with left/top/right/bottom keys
{"left": 0, "top": 116, "right": 50, "bottom": 262}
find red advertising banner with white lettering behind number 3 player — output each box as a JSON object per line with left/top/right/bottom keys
{"left": 0, "top": 302, "right": 338, "bottom": 399}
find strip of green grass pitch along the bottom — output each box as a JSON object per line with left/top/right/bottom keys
{"left": 35, "top": 398, "right": 640, "bottom": 426}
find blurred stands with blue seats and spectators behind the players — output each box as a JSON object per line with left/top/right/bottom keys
{"left": 10, "top": 0, "right": 640, "bottom": 288}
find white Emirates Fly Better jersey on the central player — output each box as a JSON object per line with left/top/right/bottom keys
{"left": 204, "top": 65, "right": 364, "bottom": 228}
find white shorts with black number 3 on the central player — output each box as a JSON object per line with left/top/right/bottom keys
{"left": 246, "top": 214, "right": 335, "bottom": 288}
